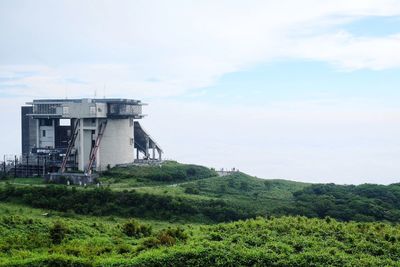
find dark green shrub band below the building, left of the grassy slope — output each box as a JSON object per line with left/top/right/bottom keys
{"left": 0, "top": 184, "right": 255, "bottom": 222}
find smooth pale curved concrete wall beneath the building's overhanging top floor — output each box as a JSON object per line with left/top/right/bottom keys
{"left": 97, "top": 118, "right": 134, "bottom": 170}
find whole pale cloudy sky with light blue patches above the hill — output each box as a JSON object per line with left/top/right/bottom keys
{"left": 0, "top": 0, "right": 400, "bottom": 184}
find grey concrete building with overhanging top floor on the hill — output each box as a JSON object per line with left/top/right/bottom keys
{"left": 21, "top": 99, "right": 162, "bottom": 174}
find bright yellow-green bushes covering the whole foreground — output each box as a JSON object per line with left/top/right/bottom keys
{"left": 0, "top": 210, "right": 400, "bottom": 266}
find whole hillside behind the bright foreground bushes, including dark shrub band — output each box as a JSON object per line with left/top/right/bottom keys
{"left": 0, "top": 162, "right": 400, "bottom": 223}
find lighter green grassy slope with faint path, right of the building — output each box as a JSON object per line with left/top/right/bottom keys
{"left": 101, "top": 162, "right": 309, "bottom": 214}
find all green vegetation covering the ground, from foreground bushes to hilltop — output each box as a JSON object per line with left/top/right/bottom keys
{"left": 0, "top": 162, "right": 400, "bottom": 266}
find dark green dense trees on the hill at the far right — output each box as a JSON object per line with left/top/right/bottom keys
{"left": 281, "top": 184, "right": 400, "bottom": 222}
